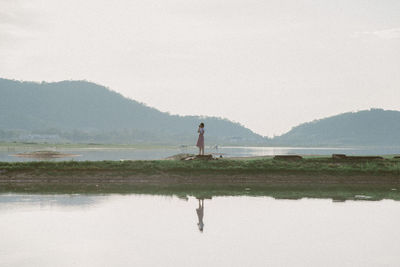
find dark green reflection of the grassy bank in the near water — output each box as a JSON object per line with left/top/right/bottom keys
{"left": 0, "top": 184, "right": 400, "bottom": 201}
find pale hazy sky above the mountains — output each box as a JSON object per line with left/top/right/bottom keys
{"left": 0, "top": 0, "right": 400, "bottom": 136}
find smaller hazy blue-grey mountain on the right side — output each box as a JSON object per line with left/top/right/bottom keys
{"left": 269, "top": 109, "right": 400, "bottom": 146}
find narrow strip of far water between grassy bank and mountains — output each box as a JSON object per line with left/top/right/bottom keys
{"left": 0, "top": 147, "right": 400, "bottom": 162}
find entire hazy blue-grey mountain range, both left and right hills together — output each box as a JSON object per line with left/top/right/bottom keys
{"left": 0, "top": 78, "right": 400, "bottom": 147}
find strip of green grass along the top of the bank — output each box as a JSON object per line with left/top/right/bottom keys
{"left": 0, "top": 158, "right": 400, "bottom": 175}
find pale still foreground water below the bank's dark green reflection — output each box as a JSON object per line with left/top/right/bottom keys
{"left": 0, "top": 194, "right": 400, "bottom": 266}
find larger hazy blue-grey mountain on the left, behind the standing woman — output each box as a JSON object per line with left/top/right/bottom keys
{"left": 0, "top": 79, "right": 265, "bottom": 145}
